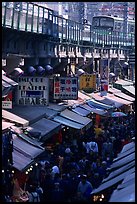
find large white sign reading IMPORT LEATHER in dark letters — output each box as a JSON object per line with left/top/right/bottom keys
{"left": 17, "top": 77, "right": 49, "bottom": 106}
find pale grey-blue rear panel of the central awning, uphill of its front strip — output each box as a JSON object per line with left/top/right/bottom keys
{"left": 60, "top": 109, "right": 92, "bottom": 128}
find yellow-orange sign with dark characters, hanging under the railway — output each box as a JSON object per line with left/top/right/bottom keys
{"left": 79, "top": 74, "right": 96, "bottom": 90}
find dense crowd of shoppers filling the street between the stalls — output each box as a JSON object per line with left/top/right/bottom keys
{"left": 2, "top": 112, "right": 135, "bottom": 202}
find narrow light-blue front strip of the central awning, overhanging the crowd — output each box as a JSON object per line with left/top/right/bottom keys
{"left": 53, "top": 116, "right": 84, "bottom": 130}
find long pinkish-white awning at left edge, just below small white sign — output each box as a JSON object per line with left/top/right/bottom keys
{"left": 2, "top": 110, "right": 29, "bottom": 127}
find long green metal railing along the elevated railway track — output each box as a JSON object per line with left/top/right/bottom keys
{"left": 2, "top": 2, "right": 135, "bottom": 48}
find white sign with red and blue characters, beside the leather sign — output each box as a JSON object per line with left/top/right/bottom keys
{"left": 54, "top": 77, "right": 78, "bottom": 100}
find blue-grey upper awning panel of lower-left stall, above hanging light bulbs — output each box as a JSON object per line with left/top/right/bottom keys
{"left": 13, "top": 136, "right": 44, "bottom": 159}
